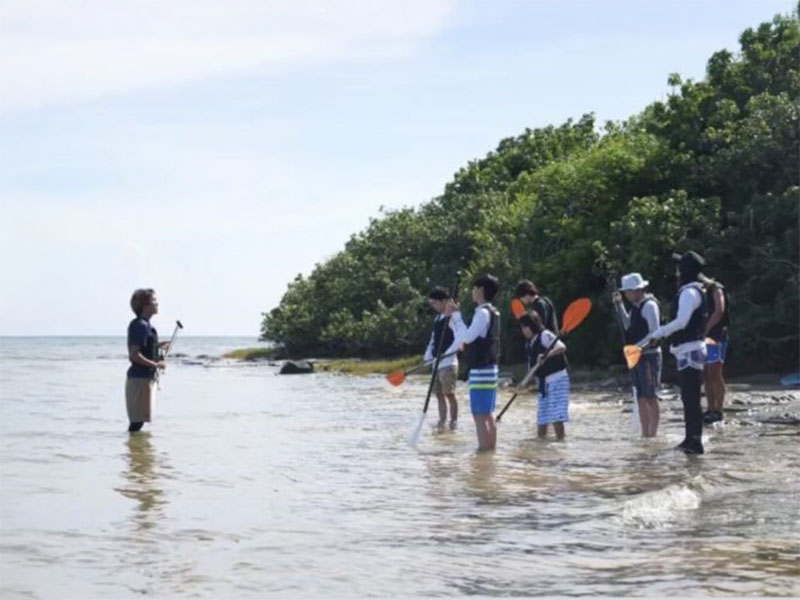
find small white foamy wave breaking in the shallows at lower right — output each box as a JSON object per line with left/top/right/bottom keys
{"left": 622, "top": 477, "right": 709, "bottom": 528}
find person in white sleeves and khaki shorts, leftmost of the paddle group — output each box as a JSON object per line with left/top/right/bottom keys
{"left": 424, "top": 286, "right": 458, "bottom": 433}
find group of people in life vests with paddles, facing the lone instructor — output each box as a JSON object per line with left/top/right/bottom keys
{"left": 425, "top": 251, "right": 730, "bottom": 454}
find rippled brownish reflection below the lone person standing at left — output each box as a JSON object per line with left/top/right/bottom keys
{"left": 117, "top": 432, "right": 167, "bottom": 530}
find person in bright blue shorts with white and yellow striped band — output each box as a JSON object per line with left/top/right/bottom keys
{"left": 445, "top": 275, "right": 500, "bottom": 451}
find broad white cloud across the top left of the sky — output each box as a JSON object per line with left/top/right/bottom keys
{"left": 0, "top": 0, "right": 454, "bottom": 110}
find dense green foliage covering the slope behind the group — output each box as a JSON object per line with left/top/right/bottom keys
{"left": 262, "top": 15, "right": 800, "bottom": 370}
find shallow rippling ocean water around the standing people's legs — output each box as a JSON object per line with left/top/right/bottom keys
{"left": 0, "top": 337, "right": 800, "bottom": 598}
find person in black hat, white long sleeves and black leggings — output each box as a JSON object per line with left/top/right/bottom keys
{"left": 646, "top": 251, "right": 708, "bottom": 454}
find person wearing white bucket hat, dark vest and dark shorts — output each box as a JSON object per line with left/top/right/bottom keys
{"left": 613, "top": 273, "right": 662, "bottom": 437}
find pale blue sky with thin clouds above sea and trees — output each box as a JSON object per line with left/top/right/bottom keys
{"left": 0, "top": 0, "right": 794, "bottom": 337}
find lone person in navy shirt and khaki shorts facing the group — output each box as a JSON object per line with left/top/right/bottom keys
{"left": 125, "top": 289, "right": 169, "bottom": 433}
